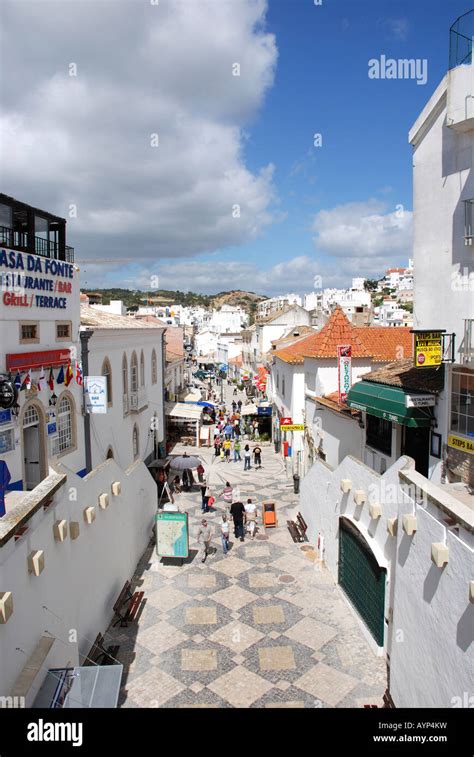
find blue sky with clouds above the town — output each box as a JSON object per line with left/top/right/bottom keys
{"left": 0, "top": 0, "right": 470, "bottom": 296}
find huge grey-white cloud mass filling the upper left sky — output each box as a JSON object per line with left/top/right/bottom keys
{"left": 0, "top": 0, "right": 277, "bottom": 260}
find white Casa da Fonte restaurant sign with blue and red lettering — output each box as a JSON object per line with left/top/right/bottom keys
{"left": 0, "top": 249, "right": 74, "bottom": 310}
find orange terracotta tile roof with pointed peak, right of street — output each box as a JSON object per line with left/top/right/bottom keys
{"left": 273, "top": 306, "right": 413, "bottom": 365}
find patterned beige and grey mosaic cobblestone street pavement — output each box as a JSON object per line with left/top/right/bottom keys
{"left": 107, "top": 416, "right": 386, "bottom": 708}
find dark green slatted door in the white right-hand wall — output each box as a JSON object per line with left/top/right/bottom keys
{"left": 339, "top": 518, "right": 386, "bottom": 647}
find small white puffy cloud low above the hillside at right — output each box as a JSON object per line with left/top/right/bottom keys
{"left": 312, "top": 200, "right": 413, "bottom": 260}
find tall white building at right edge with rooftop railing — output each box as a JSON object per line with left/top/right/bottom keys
{"left": 409, "top": 17, "right": 474, "bottom": 488}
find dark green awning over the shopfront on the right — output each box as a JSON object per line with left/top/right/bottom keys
{"left": 347, "top": 381, "right": 433, "bottom": 428}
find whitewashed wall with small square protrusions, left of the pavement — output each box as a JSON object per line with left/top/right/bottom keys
{"left": 0, "top": 460, "right": 156, "bottom": 706}
